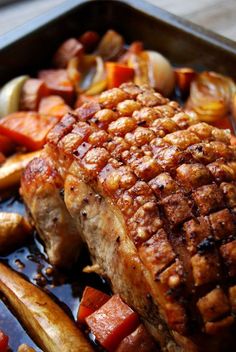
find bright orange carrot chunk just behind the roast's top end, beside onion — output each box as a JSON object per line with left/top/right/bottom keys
{"left": 106, "top": 62, "right": 134, "bottom": 89}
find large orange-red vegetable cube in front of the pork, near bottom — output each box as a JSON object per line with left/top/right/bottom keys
{"left": 85, "top": 295, "right": 139, "bottom": 352}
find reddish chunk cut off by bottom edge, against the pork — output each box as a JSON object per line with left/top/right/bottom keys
{"left": 116, "top": 324, "right": 158, "bottom": 352}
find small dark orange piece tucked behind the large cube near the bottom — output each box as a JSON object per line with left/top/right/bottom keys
{"left": 77, "top": 286, "right": 110, "bottom": 324}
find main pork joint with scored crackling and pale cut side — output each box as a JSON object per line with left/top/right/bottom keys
{"left": 22, "top": 83, "right": 236, "bottom": 352}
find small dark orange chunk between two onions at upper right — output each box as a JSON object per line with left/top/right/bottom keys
{"left": 174, "top": 67, "right": 196, "bottom": 95}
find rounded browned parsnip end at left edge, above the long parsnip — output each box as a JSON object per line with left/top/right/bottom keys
{"left": 0, "top": 213, "right": 31, "bottom": 254}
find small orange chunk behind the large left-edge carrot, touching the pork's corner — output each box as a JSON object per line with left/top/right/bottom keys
{"left": 38, "top": 95, "right": 71, "bottom": 118}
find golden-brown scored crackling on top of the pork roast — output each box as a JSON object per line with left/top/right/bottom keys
{"left": 44, "top": 83, "right": 236, "bottom": 346}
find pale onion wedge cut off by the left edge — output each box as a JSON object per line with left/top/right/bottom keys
{"left": 0, "top": 76, "right": 29, "bottom": 118}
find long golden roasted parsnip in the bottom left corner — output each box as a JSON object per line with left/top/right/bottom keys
{"left": 0, "top": 263, "right": 94, "bottom": 352}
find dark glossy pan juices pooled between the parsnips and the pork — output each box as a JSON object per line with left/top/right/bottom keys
{"left": 0, "top": 195, "right": 109, "bottom": 352}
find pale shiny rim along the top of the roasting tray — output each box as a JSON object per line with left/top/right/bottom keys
{"left": 0, "top": 0, "right": 236, "bottom": 54}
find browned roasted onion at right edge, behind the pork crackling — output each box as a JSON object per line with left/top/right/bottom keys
{"left": 186, "top": 71, "right": 236, "bottom": 122}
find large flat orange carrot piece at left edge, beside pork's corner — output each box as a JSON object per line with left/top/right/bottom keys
{"left": 0, "top": 111, "right": 58, "bottom": 151}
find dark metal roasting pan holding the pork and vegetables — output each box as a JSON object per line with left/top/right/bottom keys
{"left": 0, "top": 0, "right": 236, "bottom": 352}
